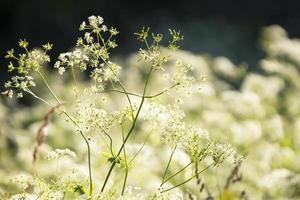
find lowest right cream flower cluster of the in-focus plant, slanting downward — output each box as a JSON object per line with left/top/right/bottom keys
{"left": 142, "top": 102, "right": 235, "bottom": 165}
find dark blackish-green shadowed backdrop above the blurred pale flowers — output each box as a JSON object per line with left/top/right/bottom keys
{"left": 0, "top": 0, "right": 300, "bottom": 85}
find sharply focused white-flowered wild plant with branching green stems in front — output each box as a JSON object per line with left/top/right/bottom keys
{"left": 4, "top": 16, "right": 235, "bottom": 199}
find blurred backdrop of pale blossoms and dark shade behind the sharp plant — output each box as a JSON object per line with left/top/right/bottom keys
{"left": 0, "top": 0, "right": 300, "bottom": 200}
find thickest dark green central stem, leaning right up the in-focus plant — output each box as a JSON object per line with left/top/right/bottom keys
{"left": 101, "top": 66, "right": 153, "bottom": 192}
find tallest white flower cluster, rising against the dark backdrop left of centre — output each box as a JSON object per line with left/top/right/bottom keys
{"left": 54, "top": 16, "right": 121, "bottom": 92}
